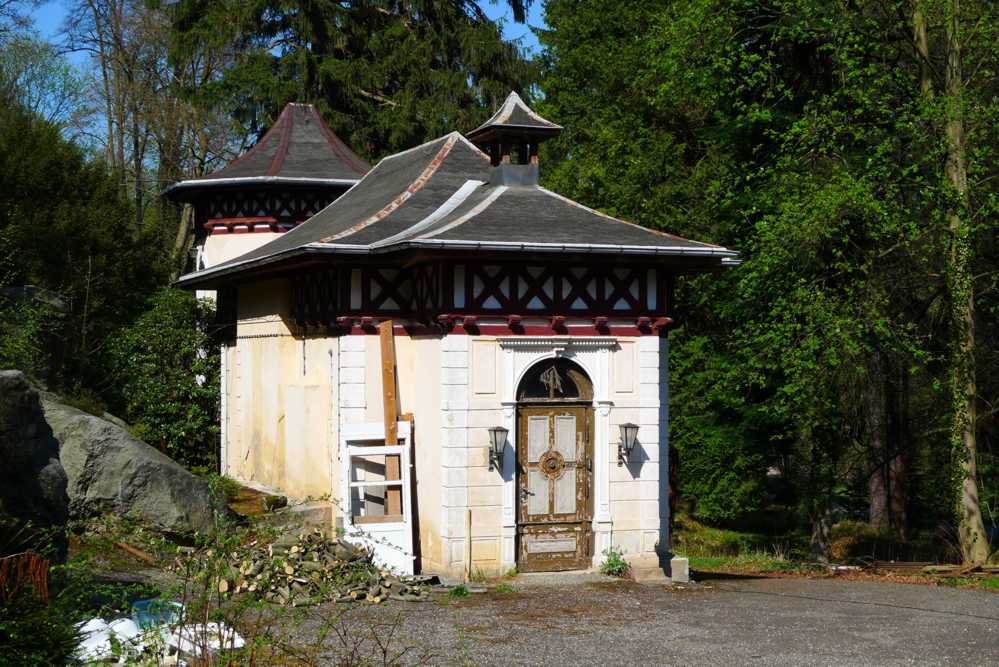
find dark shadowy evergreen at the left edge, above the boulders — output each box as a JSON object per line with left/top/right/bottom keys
{"left": 0, "top": 94, "right": 164, "bottom": 394}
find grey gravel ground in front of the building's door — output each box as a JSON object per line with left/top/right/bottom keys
{"left": 302, "top": 575, "right": 999, "bottom": 667}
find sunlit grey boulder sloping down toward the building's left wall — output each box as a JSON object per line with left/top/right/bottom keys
{"left": 42, "top": 394, "right": 226, "bottom": 533}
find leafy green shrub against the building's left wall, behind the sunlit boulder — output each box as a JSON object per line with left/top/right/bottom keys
{"left": 110, "top": 289, "right": 219, "bottom": 465}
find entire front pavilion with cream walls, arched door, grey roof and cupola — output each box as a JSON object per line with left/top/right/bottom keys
{"left": 177, "top": 94, "right": 735, "bottom": 577}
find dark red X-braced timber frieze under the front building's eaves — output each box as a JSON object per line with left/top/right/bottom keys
{"left": 291, "top": 262, "right": 673, "bottom": 328}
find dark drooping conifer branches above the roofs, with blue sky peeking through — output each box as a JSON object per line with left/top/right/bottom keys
{"left": 172, "top": 0, "right": 533, "bottom": 159}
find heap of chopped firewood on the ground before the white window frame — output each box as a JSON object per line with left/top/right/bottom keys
{"left": 209, "top": 529, "right": 428, "bottom": 606}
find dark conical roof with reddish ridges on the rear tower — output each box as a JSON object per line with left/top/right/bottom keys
{"left": 164, "top": 103, "right": 371, "bottom": 196}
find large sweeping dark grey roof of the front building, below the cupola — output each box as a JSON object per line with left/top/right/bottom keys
{"left": 174, "top": 93, "right": 736, "bottom": 285}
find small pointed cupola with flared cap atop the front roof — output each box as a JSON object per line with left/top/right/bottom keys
{"left": 467, "top": 92, "right": 562, "bottom": 166}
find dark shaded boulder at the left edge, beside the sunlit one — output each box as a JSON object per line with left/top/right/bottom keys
{"left": 0, "top": 371, "right": 67, "bottom": 527}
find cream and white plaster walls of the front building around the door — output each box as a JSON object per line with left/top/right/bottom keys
{"left": 225, "top": 290, "right": 668, "bottom": 575}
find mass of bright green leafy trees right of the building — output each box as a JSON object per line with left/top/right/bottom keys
{"left": 540, "top": 0, "right": 999, "bottom": 544}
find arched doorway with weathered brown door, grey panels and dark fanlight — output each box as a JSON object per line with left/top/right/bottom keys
{"left": 517, "top": 358, "right": 593, "bottom": 572}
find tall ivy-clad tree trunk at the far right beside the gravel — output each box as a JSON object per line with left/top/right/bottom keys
{"left": 946, "top": 0, "right": 989, "bottom": 563}
